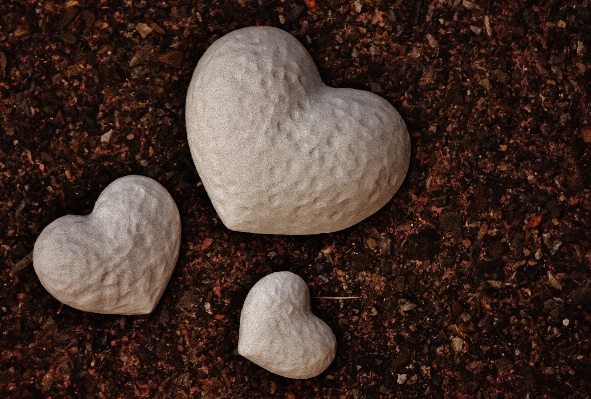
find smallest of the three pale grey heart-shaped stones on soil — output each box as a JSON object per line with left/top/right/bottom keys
{"left": 238, "top": 272, "right": 337, "bottom": 379}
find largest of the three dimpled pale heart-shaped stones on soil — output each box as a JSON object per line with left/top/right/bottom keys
{"left": 186, "top": 27, "right": 410, "bottom": 234}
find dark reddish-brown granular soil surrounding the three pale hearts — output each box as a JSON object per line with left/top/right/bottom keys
{"left": 0, "top": 0, "right": 591, "bottom": 399}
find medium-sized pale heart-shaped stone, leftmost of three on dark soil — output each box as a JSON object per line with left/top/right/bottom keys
{"left": 33, "top": 175, "right": 181, "bottom": 314}
